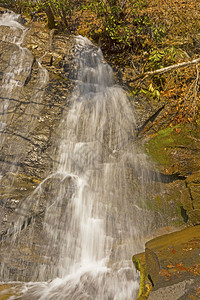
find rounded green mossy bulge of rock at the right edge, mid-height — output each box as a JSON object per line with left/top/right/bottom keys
{"left": 145, "top": 124, "right": 200, "bottom": 176}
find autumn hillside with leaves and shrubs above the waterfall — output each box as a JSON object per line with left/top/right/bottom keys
{"left": 0, "top": 0, "right": 200, "bottom": 126}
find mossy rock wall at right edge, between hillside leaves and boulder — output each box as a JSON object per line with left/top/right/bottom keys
{"left": 145, "top": 123, "right": 200, "bottom": 225}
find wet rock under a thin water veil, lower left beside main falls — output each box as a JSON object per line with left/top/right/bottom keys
{"left": 0, "top": 174, "right": 75, "bottom": 282}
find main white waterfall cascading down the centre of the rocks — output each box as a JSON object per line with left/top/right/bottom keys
{"left": 2, "top": 11, "right": 160, "bottom": 300}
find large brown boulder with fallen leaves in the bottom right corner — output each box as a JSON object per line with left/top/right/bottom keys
{"left": 133, "top": 225, "right": 200, "bottom": 300}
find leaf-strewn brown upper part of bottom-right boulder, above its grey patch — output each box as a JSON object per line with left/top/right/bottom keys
{"left": 146, "top": 226, "right": 200, "bottom": 284}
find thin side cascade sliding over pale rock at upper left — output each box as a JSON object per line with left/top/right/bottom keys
{"left": 0, "top": 12, "right": 48, "bottom": 172}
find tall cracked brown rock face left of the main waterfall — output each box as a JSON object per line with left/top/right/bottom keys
{"left": 0, "top": 13, "right": 73, "bottom": 274}
